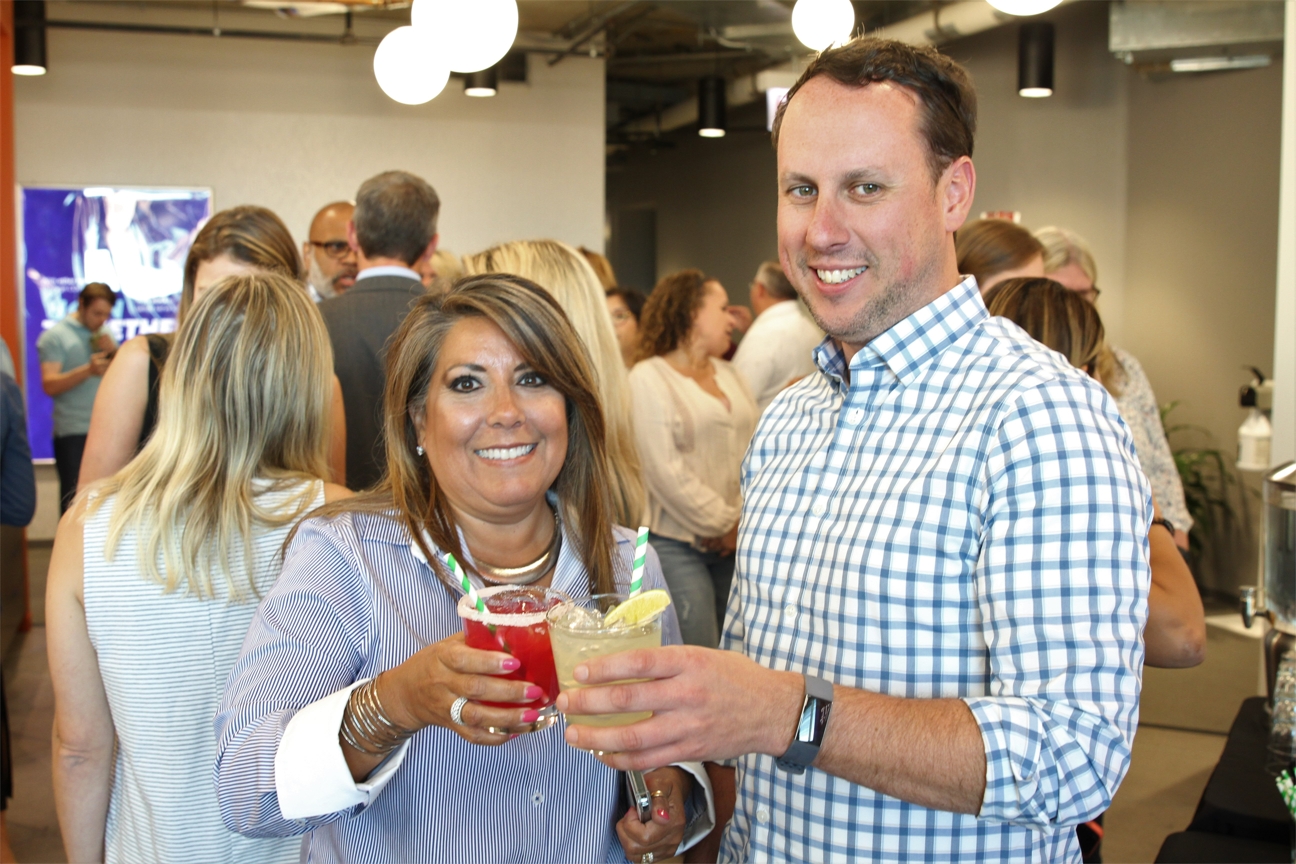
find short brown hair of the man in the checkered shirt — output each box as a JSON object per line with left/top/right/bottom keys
{"left": 774, "top": 36, "right": 976, "bottom": 181}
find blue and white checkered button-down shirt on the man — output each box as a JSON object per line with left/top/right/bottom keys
{"left": 721, "top": 277, "right": 1152, "bottom": 861}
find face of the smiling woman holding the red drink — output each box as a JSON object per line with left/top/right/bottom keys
{"left": 415, "top": 317, "right": 568, "bottom": 523}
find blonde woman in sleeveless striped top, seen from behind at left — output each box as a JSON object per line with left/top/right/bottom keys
{"left": 45, "top": 275, "right": 349, "bottom": 864}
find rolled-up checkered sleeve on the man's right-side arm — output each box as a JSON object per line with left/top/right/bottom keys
{"left": 964, "top": 380, "right": 1152, "bottom": 826}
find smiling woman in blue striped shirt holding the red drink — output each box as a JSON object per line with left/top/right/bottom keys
{"left": 216, "top": 273, "right": 713, "bottom": 864}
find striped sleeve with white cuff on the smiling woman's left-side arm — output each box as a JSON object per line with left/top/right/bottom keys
{"left": 214, "top": 521, "right": 378, "bottom": 837}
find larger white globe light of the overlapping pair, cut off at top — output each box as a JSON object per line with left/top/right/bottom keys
{"left": 410, "top": 0, "right": 517, "bottom": 73}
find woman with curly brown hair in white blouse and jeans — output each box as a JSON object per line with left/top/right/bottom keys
{"left": 630, "top": 269, "right": 759, "bottom": 648}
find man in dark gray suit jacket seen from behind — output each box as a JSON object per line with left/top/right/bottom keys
{"left": 320, "top": 171, "right": 441, "bottom": 490}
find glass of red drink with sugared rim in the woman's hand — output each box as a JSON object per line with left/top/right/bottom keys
{"left": 459, "top": 585, "right": 572, "bottom": 732}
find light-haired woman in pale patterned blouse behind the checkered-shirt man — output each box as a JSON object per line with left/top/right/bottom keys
{"left": 1036, "top": 225, "right": 1192, "bottom": 549}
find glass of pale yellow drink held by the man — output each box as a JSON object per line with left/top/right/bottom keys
{"left": 548, "top": 595, "right": 662, "bottom": 727}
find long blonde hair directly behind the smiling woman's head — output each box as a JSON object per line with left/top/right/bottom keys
{"left": 464, "top": 240, "right": 648, "bottom": 529}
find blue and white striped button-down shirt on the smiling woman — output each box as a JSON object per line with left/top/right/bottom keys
{"left": 215, "top": 513, "right": 679, "bottom": 864}
